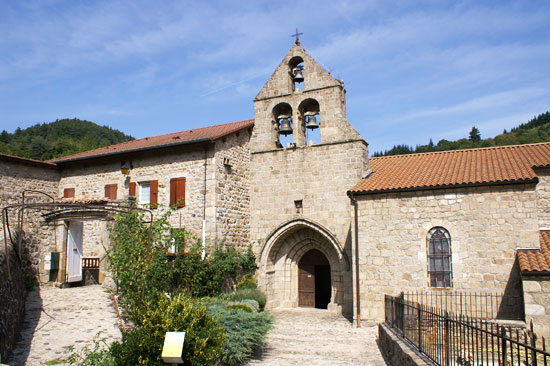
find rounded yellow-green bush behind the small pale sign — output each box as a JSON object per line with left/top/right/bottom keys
{"left": 111, "top": 295, "right": 225, "bottom": 366}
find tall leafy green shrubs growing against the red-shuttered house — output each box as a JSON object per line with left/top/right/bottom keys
{"left": 110, "top": 210, "right": 256, "bottom": 319}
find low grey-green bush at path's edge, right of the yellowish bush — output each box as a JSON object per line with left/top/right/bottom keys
{"left": 207, "top": 303, "right": 273, "bottom": 365}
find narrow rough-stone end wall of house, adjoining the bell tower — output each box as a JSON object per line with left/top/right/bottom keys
{"left": 215, "top": 130, "right": 250, "bottom": 248}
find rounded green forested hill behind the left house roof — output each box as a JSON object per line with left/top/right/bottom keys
{"left": 0, "top": 118, "right": 134, "bottom": 160}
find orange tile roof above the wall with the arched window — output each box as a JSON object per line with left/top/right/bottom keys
{"left": 351, "top": 142, "right": 550, "bottom": 193}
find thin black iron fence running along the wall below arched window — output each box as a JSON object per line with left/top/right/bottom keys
{"left": 404, "top": 291, "right": 524, "bottom": 320}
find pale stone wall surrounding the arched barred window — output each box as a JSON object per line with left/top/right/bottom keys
{"left": 354, "top": 185, "right": 539, "bottom": 321}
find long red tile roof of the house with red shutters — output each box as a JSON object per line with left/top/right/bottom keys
{"left": 48, "top": 119, "right": 254, "bottom": 163}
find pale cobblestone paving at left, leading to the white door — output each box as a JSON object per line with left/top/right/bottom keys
{"left": 8, "top": 285, "right": 121, "bottom": 366}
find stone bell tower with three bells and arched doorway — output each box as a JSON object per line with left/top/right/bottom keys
{"left": 249, "top": 39, "right": 369, "bottom": 313}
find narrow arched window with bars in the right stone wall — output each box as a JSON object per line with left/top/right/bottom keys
{"left": 426, "top": 227, "right": 453, "bottom": 287}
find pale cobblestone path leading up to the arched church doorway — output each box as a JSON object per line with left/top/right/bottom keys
{"left": 248, "top": 309, "right": 389, "bottom": 366}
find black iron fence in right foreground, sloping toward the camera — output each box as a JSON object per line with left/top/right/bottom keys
{"left": 385, "top": 294, "right": 550, "bottom": 366}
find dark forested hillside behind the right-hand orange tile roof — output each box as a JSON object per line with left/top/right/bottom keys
{"left": 373, "top": 112, "right": 550, "bottom": 156}
